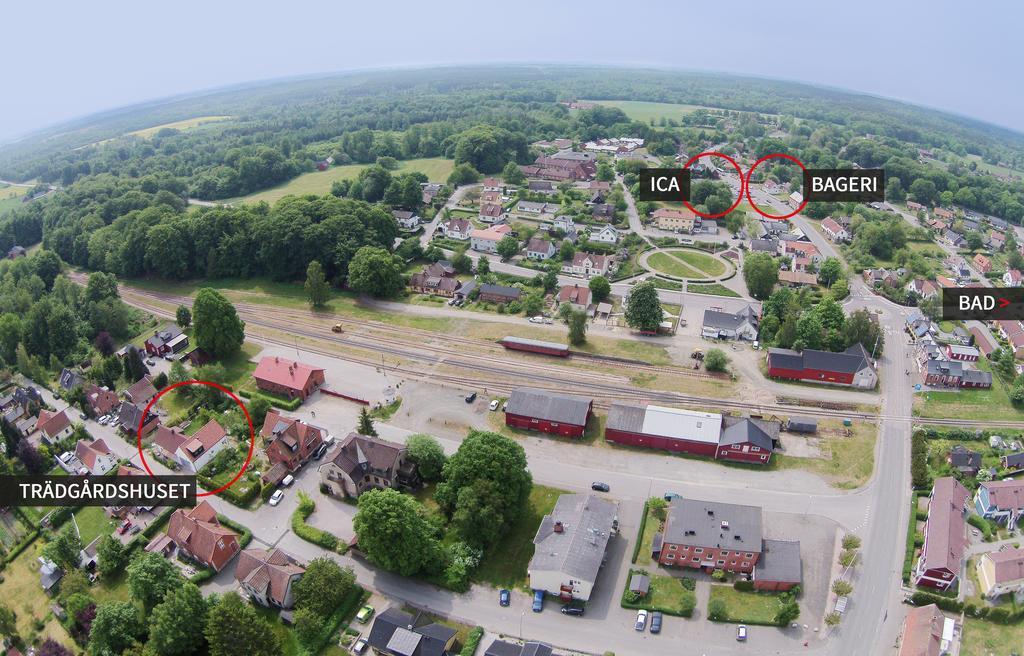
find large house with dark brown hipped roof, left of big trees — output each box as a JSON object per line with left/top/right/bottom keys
{"left": 318, "top": 433, "right": 419, "bottom": 498}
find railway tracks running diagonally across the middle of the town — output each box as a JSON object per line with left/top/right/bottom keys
{"left": 72, "top": 274, "right": 1024, "bottom": 429}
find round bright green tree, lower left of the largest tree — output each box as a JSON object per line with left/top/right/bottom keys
{"left": 352, "top": 489, "right": 440, "bottom": 576}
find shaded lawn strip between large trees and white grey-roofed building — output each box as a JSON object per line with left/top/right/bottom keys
{"left": 473, "top": 483, "right": 566, "bottom": 588}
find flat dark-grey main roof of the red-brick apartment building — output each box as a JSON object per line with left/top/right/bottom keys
{"left": 665, "top": 498, "right": 764, "bottom": 552}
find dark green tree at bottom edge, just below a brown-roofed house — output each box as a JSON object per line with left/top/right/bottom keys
{"left": 206, "top": 593, "right": 282, "bottom": 656}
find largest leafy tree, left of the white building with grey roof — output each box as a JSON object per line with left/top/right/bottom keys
{"left": 434, "top": 430, "right": 534, "bottom": 546}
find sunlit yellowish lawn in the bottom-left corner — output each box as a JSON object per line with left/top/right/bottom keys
{"left": 0, "top": 539, "right": 71, "bottom": 645}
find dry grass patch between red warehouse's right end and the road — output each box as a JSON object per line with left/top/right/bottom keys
{"left": 769, "top": 420, "right": 878, "bottom": 489}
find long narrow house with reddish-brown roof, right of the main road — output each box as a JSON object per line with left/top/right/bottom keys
{"left": 913, "top": 476, "right": 971, "bottom": 591}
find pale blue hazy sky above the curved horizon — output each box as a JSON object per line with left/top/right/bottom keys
{"left": 0, "top": 0, "right": 1024, "bottom": 139}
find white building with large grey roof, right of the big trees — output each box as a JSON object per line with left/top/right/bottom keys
{"left": 526, "top": 494, "right": 618, "bottom": 602}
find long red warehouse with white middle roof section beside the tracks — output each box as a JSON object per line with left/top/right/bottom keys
{"left": 604, "top": 403, "right": 778, "bottom": 465}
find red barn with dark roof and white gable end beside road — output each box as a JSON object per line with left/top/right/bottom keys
{"left": 768, "top": 343, "right": 879, "bottom": 390}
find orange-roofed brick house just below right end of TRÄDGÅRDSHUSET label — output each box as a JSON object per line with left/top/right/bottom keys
{"left": 145, "top": 501, "right": 240, "bottom": 572}
